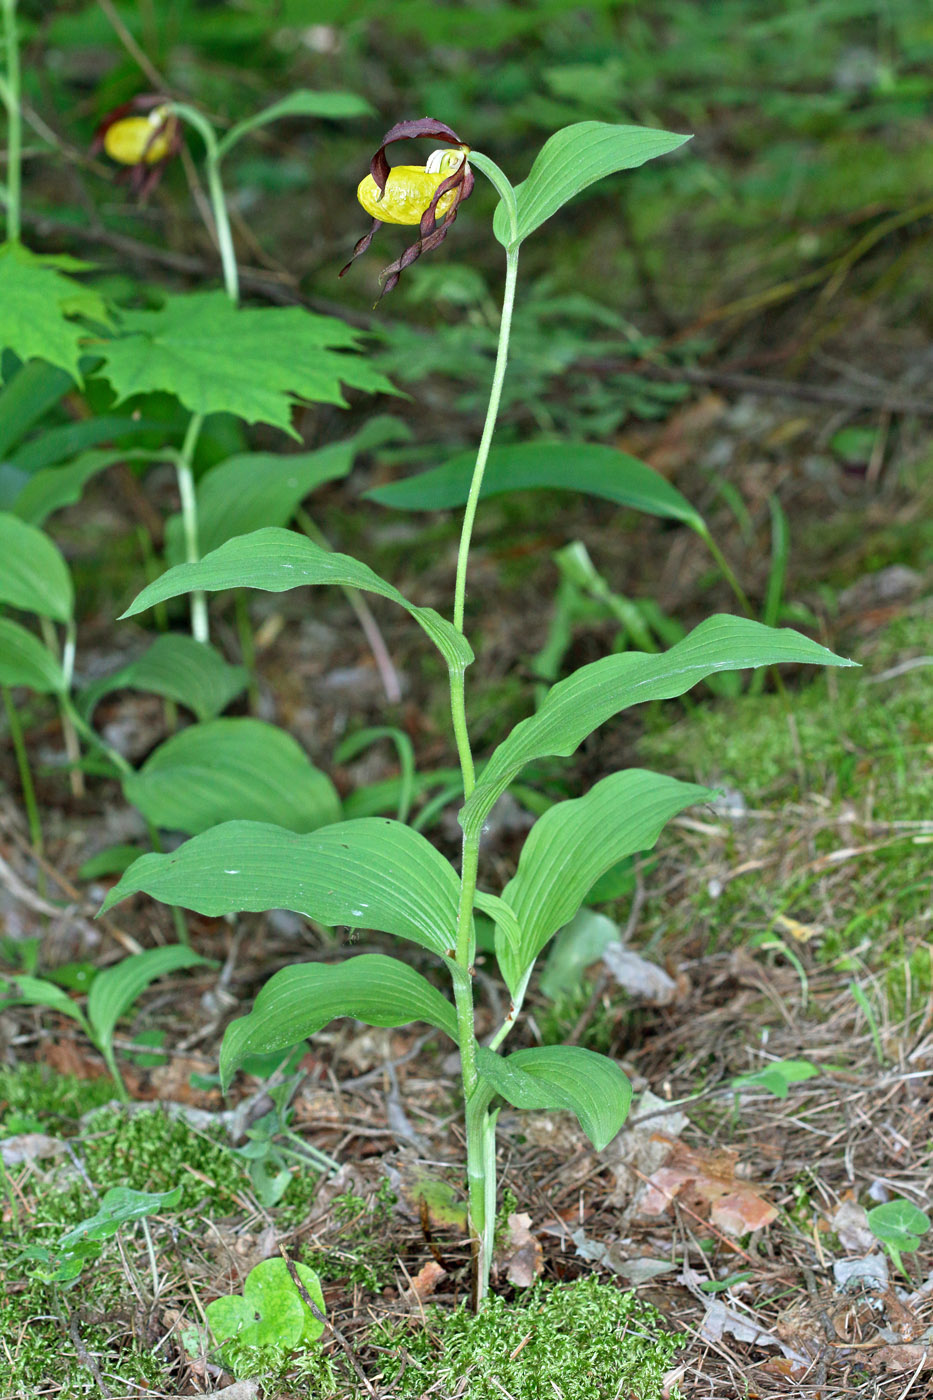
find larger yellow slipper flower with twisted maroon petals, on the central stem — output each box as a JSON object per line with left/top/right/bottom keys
{"left": 340, "top": 116, "right": 474, "bottom": 295}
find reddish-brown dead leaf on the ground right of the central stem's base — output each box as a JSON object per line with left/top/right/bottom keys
{"left": 636, "top": 1142, "right": 778, "bottom": 1235}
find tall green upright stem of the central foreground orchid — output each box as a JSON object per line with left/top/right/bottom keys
{"left": 450, "top": 153, "right": 520, "bottom": 1309}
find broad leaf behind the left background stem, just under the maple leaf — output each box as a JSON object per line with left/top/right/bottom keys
{"left": 165, "top": 438, "right": 356, "bottom": 563}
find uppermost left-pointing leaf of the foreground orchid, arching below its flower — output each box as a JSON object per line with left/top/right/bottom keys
{"left": 123, "top": 526, "right": 474, "bottom": 669}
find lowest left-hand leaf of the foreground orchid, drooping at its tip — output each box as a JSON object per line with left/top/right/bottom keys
{"left": 220, "top": 953, "right": 457, "bottom": 1092}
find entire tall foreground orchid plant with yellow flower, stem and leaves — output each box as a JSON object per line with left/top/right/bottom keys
{"left": 105, "top": 109, "right": 846, "bottom": 1306}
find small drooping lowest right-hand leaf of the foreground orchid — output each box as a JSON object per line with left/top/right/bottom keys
{"left": 476, "top": 1046, "right": 632, "bottom": 1151}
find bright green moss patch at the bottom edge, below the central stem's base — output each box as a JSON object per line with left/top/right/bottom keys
{"left": 374, "top": 1277, "right": 685, "bottom": 1400}
